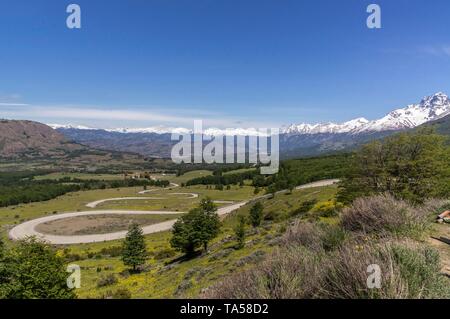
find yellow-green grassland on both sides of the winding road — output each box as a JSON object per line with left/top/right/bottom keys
{"left": 0, "top": 171, "right": 336, "bottom": 298}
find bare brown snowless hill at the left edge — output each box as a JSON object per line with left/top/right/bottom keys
{"left": 0, "top": 120, "right": 151, "bottom": 171}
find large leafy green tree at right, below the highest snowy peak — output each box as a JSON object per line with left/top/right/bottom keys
{"left": 338, "top": 129, "right": 449, "bottom": 203}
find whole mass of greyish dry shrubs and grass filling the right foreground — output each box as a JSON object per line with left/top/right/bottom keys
{"left": 203, "top": 195, "right": 450, "bottom": 299}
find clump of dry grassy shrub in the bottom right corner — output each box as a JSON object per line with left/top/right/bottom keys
{"left": 320, "top": 242, "right": 450, "bottom": 299}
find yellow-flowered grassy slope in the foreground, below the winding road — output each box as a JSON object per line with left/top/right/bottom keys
{"left": 70, "top": 186, "right": 336, "bottom": 298}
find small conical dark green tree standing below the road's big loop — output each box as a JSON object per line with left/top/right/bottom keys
{"left": 122, "top": 223, "right": 147, "bottom": 271}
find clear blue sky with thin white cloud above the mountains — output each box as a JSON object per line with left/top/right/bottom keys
{"left": 0, "top": 0, "right": 450, "bottom": 127}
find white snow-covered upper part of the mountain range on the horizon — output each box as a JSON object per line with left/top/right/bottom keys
{"left": 48, "top": 92, "right": 450, "bottom": 136}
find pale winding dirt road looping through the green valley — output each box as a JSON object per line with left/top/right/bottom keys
{"left": 9, "top": 179, "right": 339, "bottom": 245}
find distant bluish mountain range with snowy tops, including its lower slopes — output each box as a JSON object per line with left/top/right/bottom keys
{"left": 50, "top": 92, "right": 450, "bottom": 157}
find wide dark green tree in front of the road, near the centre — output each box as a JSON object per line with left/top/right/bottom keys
{"left": 170, "top": 199, "right": 220, "bottom": 255}
